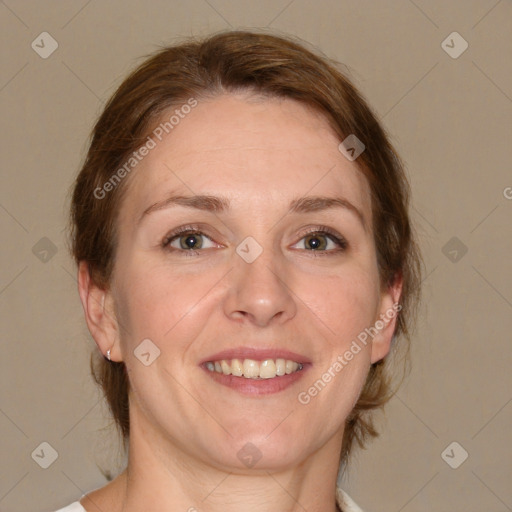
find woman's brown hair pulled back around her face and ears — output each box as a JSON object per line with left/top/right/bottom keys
{"left": 71, "top": 31, "right": 421, "bottom": 468}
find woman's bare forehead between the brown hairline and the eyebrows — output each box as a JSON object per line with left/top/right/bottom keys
{"left": 123, "top": 94, "right": 371, "bottom": 221}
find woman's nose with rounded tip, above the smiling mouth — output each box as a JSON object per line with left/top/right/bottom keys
{"left": 224, "top": 245, "right": 297, "bottom": 327}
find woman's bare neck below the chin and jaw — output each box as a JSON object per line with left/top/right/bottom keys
{"left": 116, "top": 412, "right": 343, "bottom": 512}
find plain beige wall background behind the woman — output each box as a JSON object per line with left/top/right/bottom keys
{"left": 0, "top": 0, "right": 512, "bottom": 512}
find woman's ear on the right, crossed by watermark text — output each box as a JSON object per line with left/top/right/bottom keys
{"left": 371, "top": 274, "right": 403, "bottom": 364}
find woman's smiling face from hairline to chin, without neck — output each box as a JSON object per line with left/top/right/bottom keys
{"left": 105, "top": 95, "right": 396, "bottom": 471}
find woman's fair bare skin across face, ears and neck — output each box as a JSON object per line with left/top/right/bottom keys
{"left": 79, "top": 94, "right": 401, "bottom": 512}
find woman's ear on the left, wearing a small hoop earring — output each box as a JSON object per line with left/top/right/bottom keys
{"left": 78, "top": 261, "right": 122, "bottom": 361}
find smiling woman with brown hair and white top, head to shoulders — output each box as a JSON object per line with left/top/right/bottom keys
{"left": 62, "top": 32, "right": 420, "bottom": 512}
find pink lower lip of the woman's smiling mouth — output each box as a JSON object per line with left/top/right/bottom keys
{"left": 203, "top": 364, "right": 310, "bottom": 396}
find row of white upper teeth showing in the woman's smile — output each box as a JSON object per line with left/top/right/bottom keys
{"left": 205, "top": 359, "right": 303, "bottom": 379}
